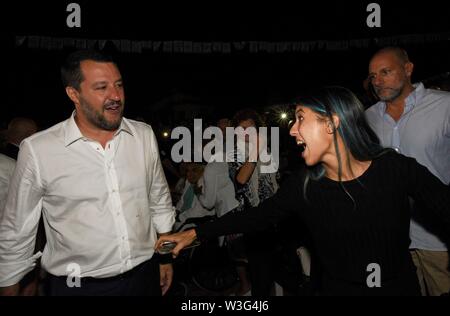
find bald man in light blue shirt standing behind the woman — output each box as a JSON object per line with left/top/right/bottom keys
{"left": 366, "top": 47, "right": 450, "bottom": 295}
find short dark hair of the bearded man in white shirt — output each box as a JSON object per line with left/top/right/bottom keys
{"left": 61, "top": 50, "right": 114, "bottom": 91}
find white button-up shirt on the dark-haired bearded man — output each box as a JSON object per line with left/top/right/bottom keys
{"left": 0, "top": 114, "right": 175, "bottom": 286}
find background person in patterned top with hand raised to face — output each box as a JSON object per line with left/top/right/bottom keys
{"left": 226, "top": 109, "right": 278, "bottom": 296}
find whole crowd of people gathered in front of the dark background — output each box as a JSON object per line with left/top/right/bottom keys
{"left": 0, "top": 47, "right": 450, "bottom": 297}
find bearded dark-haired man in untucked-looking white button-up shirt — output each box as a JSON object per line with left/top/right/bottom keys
{"left": 0, "top": 51, "right": 175, "bottom": 295}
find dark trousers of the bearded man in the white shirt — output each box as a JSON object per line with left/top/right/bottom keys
{"left": 48, "top": 258, "right": 161, "bottom": 296}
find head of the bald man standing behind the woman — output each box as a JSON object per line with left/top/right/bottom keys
{"left": 369, "top": 52, "right": 413, "bottom": 102}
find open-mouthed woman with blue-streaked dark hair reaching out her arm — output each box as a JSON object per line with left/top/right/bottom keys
{"left": 157, "top": 87, "right": 450, "bottom": 295}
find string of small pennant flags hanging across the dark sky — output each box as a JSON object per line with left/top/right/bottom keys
{"left": 15, "top": 32, "right": 450, "bottom": 54}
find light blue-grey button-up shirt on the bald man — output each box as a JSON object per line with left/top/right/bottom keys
{"left": 366, "top": 83, "right": 450, "bottom": 251}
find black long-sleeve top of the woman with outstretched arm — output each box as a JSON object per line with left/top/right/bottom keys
{"left": 196, "top": 152, "right": 450, "bottom": 295}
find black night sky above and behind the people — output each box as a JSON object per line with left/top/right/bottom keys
{"left": 0, "top": 1, "right": 450, "bottom": 128}
